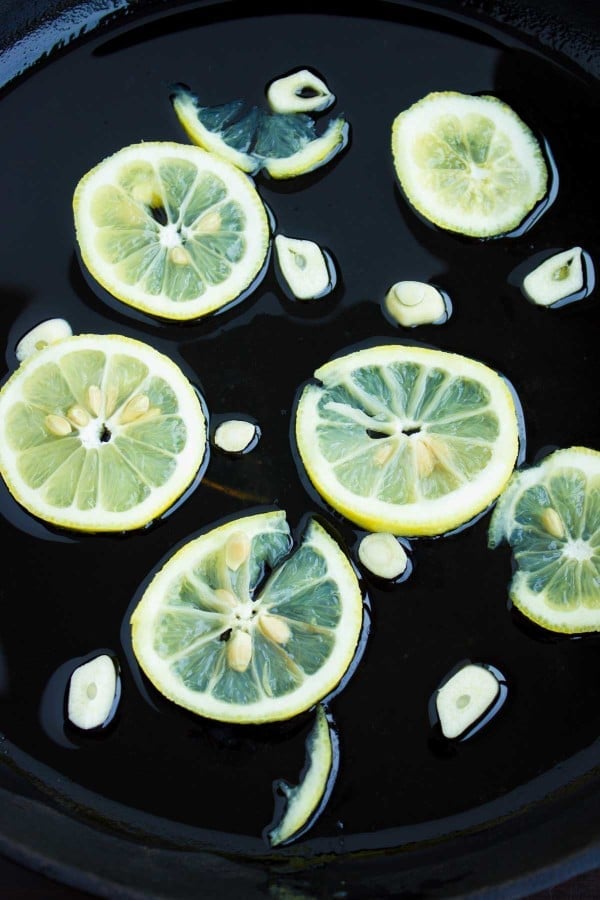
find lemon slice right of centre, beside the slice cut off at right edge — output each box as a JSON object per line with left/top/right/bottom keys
{"left": 295, "top": 344, "right": 519, "bottom": 536}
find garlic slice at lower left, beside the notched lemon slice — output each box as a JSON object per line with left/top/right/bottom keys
{"left": 67, "top": 654, "right": 117, "bottom": 731}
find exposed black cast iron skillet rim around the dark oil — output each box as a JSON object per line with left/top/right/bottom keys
{"left": 0, "top": 0, "right": 600, "bottom": 900}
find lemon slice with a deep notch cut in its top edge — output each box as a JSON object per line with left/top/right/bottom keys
{"left": 131, "top": 511, "right": 362, "bottom": 724}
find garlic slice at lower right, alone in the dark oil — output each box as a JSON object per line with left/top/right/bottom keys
{"left": 436, "top": 663, "right": 500, "bottom": 738}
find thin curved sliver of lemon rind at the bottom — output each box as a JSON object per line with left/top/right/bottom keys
{"left": 267, "top": 705, "right": 334, "bottom": 847}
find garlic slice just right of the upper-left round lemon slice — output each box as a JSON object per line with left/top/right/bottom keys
{"left": 275, "top": 234, "right": 333, "bottom": 300}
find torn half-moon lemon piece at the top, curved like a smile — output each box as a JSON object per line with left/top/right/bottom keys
{"left": 171, "top": 85, "right": 349, "bottom": 179}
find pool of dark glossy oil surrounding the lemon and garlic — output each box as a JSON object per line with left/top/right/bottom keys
{"left": 0, "top": 3, "right": 600, "bottom": 855}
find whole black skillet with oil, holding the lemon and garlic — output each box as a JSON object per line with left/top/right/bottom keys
{"left": 0, "top": 0, "right": 600, "bottom": 900}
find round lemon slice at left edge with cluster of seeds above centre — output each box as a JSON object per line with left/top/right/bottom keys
{"left": 0, "top": 334, "right": 207, "bottom": 532}
